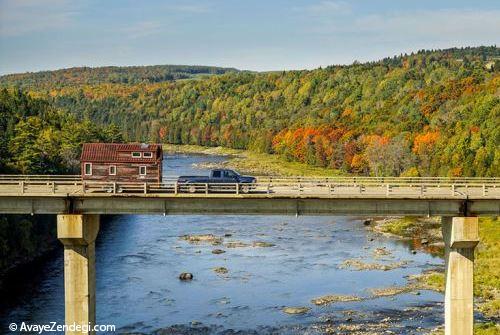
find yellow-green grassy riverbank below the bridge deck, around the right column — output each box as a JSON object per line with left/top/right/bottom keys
{"left": 371, "top": 217, "right": 500, "bottom": 335}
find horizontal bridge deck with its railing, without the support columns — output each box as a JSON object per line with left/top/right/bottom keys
{"left": 0, "top": 175, "right": 500, "bottom": 216}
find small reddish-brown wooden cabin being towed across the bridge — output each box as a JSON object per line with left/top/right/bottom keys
{"left": 80, "top": 143, "right": 163, "bottom": 182}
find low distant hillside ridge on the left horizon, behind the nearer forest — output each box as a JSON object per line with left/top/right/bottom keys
{"left": 0, "top": 65, "right": 238, "bottom": 88}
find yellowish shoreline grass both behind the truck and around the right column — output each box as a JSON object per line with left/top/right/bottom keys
{"left": 164, "top": 144, "right": 500, "bottom": 335}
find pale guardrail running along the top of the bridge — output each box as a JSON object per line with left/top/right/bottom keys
{"left": 0, "top": 175, "right": 500, "bottom": 199}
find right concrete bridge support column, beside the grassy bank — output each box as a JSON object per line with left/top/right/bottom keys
{"left": 442, "top": 217, "right": 479, "bottom": 335}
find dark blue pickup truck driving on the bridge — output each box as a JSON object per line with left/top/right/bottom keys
{"left": 177, "top": 169, "right": 257, "bottom": 193}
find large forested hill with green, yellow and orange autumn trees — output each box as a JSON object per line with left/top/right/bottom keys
{"left": 0, "top": 47, "right": 500, "bottom": 176}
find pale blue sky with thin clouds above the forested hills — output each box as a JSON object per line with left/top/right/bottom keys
{"left": 0, "top": 0, "right": 500, "bottom": 74}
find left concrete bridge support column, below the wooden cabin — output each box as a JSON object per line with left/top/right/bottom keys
{"left": 57, "top": 214, "right": 99, "bottom": 335}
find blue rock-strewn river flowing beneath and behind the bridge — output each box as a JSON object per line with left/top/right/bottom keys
{"left": 0, "top": 155, "right": 443, "bottom": 334}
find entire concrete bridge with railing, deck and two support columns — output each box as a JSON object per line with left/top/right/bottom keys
{"left": 0, "top": 175, "right": 500, "bottom": 335}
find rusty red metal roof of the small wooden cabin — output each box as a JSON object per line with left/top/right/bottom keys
{"left": 80, "top": 143, "right": 162, "bottom": 163}
